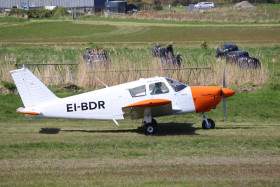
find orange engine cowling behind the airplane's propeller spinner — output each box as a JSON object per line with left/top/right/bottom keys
{"left": 191, "top": 86, "right": 222, "bottom": 113}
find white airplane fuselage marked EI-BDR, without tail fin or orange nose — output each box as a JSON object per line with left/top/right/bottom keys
{"left": 25, "top": 77, "right": 196, "bottom": 120}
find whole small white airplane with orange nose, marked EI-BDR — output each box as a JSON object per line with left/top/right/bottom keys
{"left": 10, "top": 67, "right": 235, "bottom": 135}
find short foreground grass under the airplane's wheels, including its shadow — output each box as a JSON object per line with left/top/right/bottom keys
{"left": 0, "top": 110, "right": 280, "bottom": 186}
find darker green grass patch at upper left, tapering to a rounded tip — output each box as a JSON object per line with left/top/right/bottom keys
{"left": 0, "top": 21, "right": 114, "bottom": 42}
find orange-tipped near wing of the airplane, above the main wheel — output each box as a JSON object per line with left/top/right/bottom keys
{"left": 122, "top": 99, "right": 178, "bottom": 119}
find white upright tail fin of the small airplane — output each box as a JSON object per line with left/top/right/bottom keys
{"left": 10, "top": 68, "right": 58, "bottom": 107}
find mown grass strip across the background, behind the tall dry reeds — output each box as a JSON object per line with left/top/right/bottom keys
{"left": 0, "top": 19, "right": 280, "bottom": 45}
